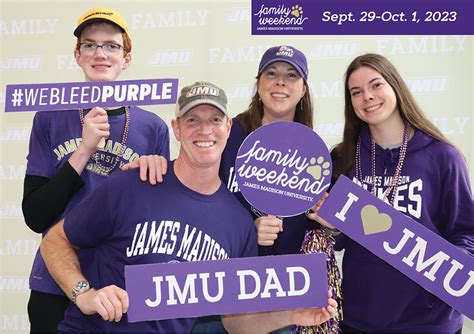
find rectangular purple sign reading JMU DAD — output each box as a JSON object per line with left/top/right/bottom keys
{"left": 125, "top": 253, "right": 328, "bottom": 322}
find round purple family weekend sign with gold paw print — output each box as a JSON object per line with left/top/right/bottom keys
{"left": 235, "top": 122, "right": 332, "bottom": 217}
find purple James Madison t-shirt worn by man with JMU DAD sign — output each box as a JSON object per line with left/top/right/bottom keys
{"left": 59, "top": 163, "right": 257, "bottom": 333}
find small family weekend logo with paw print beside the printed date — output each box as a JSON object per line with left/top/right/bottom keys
{"left": 253, "top": 4, "right": 308, "bottom": 30}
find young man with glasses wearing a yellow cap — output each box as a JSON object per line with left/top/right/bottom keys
{"left": 22, "top": 7, "right": 169, "bottom": 333}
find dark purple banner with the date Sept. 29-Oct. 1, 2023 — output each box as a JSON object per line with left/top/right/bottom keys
{"left": 251, "top": 0, "right": 474, "bottom": 35}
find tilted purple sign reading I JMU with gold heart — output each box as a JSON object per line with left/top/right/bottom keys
{"left": 319, "top": 176, "right": 474, "bottom": 319}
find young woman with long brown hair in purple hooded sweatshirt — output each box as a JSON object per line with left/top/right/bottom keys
{"left": 312, "top": 54, "right": 474, "bottom": 333}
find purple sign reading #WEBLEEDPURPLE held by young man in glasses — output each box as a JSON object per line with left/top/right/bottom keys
{"left": 5, "top": 79, "right": 178, "bottom": 112}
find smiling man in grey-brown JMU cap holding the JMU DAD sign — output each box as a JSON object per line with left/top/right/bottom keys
{"left": 41, "top": 82, "right": 335, "bottom": 333}
